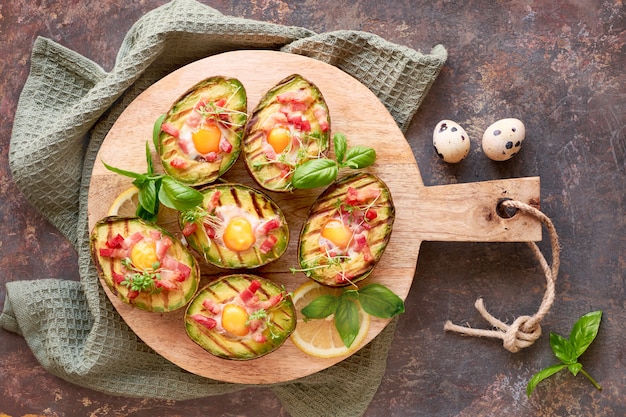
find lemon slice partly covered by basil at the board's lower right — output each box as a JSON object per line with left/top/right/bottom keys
{"left": 291, "top": 281, "right": 370, "bottom": 358}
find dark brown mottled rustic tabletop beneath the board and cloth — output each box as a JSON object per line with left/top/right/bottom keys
{"left": 0, "top": 0, "right": 626, "bottom": 416}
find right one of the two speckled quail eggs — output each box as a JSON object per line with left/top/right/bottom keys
{"left": 482, "top": 118, "right": 526, "bottom": 161}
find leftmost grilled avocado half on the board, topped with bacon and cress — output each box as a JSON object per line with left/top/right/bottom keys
{"left": 90, "top": 216, "right": 200, "bottom": 312}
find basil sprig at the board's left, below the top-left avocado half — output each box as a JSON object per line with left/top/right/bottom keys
{"left": 102, "top": 115, "right": 203, "bottom": 222}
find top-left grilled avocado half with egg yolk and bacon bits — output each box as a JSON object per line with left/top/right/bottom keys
{"left": 155, "top": 76, "right": 248, "bottom": 186}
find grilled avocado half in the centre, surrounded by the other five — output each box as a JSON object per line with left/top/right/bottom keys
{"left": 179, "top": 183, "right": 289, "bottom": 269}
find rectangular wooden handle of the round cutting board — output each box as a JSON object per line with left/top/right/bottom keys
{"left": 415, "top": 177, "right": 542, "bottom": 242}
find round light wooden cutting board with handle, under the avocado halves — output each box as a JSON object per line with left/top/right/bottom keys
{"left": 88, "top": 51, "right": 541, "bottom": 384}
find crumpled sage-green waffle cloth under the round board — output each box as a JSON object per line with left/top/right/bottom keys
{"left": 0, "top": 0, "right": 447, "bottom": 416}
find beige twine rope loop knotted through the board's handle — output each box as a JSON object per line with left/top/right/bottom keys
{"left": 444, "top": 200, "right": 561, "bottom": 353}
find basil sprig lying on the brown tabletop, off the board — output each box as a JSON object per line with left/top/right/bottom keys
{"left": 526, "top": 310, "right": 602, "bottom": 397}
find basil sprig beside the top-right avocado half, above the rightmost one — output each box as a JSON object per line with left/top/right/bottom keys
{"left": 291, "top": 133, "right": 376, "bottom": 189}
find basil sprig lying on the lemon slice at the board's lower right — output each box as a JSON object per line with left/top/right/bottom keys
{"left": 302, "top": 284, "right": 404, "bottom": 347}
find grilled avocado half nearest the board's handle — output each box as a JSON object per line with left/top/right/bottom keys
{"left": 298, "top": 172, "right": 395, "bottom": 287}
